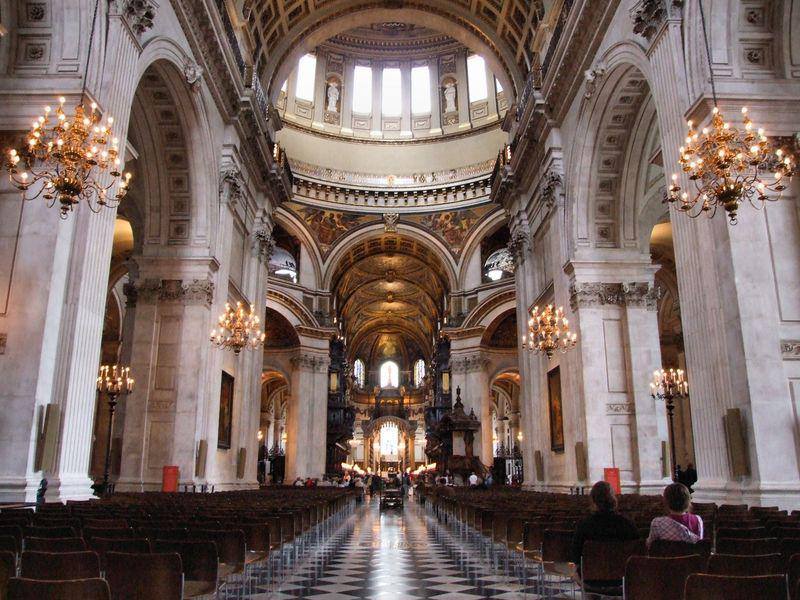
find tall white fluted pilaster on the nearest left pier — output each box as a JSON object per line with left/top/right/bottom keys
{"left": 48, "top": 5, "right": 152, "bottom": 500}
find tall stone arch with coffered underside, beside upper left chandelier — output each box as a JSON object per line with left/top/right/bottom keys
{"left": 126, "top": 51, "right": 218, "bottom": 249}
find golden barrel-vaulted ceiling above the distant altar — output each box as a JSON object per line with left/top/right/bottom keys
{"left": 333, "top": 236, "right": 448, "bottom": 356}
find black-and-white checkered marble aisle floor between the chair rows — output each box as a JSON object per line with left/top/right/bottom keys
{"left": 239, "top": 494, "right": 575, "bottom": 600}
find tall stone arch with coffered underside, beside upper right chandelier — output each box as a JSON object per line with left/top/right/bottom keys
{"left": 568, "top": 43, "right": 664, "bottom": 251}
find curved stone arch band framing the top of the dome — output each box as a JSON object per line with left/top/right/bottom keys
{"left": 260, "top": 0, "right": 525, "bottom": 102}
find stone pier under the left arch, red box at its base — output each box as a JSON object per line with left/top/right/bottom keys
{"left": 117, "top": 270, "right": 219, "bottom": 490}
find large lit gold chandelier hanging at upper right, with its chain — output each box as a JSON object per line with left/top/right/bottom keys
{"left": 667, "top": 0, "right": 795, "bottom": 224}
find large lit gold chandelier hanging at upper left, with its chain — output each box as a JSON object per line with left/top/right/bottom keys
{"left": 5, "top": 0, "right": 131, "bottom": 219}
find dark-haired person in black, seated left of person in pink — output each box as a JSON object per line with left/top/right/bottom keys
{"left": 570, "top": 481, "right": 639, "bottom": 568}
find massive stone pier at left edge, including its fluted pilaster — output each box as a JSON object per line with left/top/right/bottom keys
{"left": 0, "top": 7, "right": 152, "bottom": 501}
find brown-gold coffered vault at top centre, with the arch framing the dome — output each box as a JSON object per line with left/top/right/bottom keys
{"left": 242, "top": 0, "right": 544, "bottom": 98}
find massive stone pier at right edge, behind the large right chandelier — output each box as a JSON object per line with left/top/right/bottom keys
{"left": 648, "top": 5, "right": 800, "bottom": 508}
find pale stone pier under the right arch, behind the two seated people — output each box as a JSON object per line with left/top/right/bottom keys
{"left": 567, "top": 270, "right": 667, "bottom": 493}
